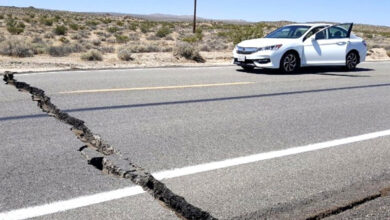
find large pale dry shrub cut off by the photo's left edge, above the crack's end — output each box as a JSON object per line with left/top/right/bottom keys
{"left": 0, "top": 38, "right": 34, "bottom": 57}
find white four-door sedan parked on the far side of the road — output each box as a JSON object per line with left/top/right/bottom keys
{"left": 233, "top": 23, "right": 367, "bottom": 73}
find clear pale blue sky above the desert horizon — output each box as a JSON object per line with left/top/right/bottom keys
{"left": 0, "top": 0, "right": 390, "bottom": 26}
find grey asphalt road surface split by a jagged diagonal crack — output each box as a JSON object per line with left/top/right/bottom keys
{"left": 0, "top": 63, "right": 390, "bottom": 219}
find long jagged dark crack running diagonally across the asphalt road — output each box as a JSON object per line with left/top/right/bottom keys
{"left": 3, "top": 72, "right": 216, "bottom": 219}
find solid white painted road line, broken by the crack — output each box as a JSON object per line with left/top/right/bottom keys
{"left": 0, "top": 130, "right": 390, "bottom": 220}
